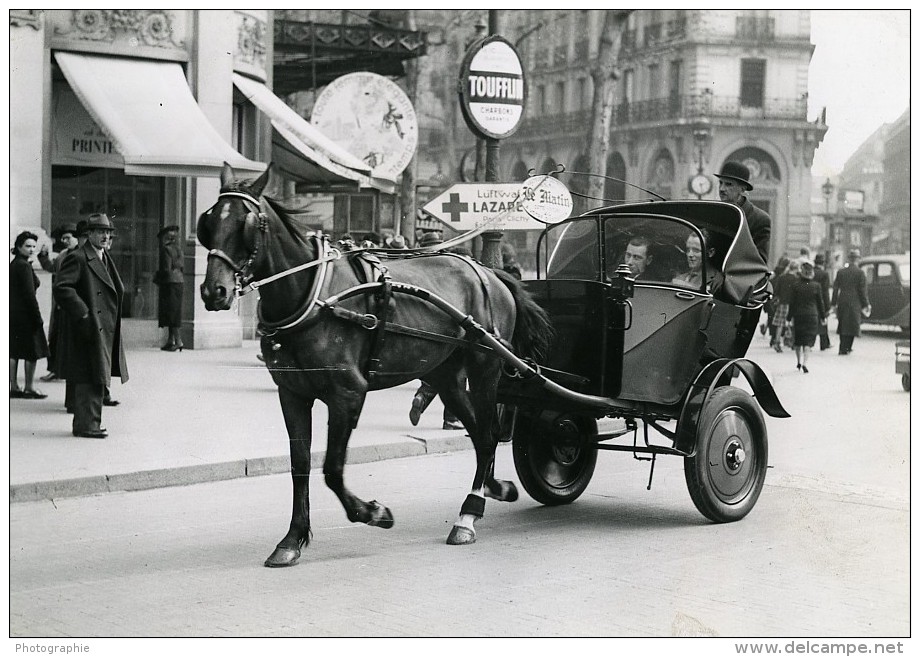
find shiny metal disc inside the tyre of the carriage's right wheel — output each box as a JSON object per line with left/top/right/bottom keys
{"left": 707, "top": 408, "right": 760, "bottom": 504}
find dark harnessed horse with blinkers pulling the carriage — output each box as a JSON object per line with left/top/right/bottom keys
{"left": 197, "top": 163, "right": 553, "bottom": 567}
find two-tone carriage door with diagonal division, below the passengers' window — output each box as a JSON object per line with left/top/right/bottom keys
{"left": 619, "top": 285, "right": 713, "bottom": 404}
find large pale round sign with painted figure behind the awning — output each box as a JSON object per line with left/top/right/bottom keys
{"left": 310, "top": 72, "right": 418, "bottom": 180}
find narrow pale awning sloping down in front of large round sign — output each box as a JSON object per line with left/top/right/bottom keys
{"left": 233, "top": 73, "right": 395, "bottom": 194}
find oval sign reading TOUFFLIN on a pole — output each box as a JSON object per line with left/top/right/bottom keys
{"left": 459, "top": 35, "right": 527, "bottom": 139}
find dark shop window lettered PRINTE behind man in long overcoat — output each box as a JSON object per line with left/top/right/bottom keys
{"left": 51, "top": 166, "right": 163, "bottom": 319}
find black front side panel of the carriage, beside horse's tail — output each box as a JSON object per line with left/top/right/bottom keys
{"left": 524, "top": 279, "right": 607, "bottom": 394}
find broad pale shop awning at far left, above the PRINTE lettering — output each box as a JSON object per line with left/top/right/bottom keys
{"left": 55, "top": 52, "right": 266, "bottom": 177}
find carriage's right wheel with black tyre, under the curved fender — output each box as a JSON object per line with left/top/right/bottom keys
{"left": 684, "top": 386, "right": 767, "bottom": 522}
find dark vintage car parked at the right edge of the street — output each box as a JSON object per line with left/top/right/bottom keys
{"left": 859, "top": 255, "right": 910, "bottom": 332}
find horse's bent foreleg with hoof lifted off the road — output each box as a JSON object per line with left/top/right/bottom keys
{"left": 323, "top": 375, "right": 393, "bottom": 529}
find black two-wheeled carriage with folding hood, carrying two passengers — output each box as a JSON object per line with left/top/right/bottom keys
{"left": 499, "top": 201, "right": 788, "bottom": 522}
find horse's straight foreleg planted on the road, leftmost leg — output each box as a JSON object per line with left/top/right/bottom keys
{"left": 265, "top": 387, "right": 314, "bottom": 568}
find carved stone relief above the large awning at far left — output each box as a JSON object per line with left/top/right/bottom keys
{"left": 55, "top": 9, "right": 182, "bottom": 48}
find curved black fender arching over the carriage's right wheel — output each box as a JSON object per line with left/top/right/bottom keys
{"left": 674, "top": 358, "right": 790, "bottom": 456}
